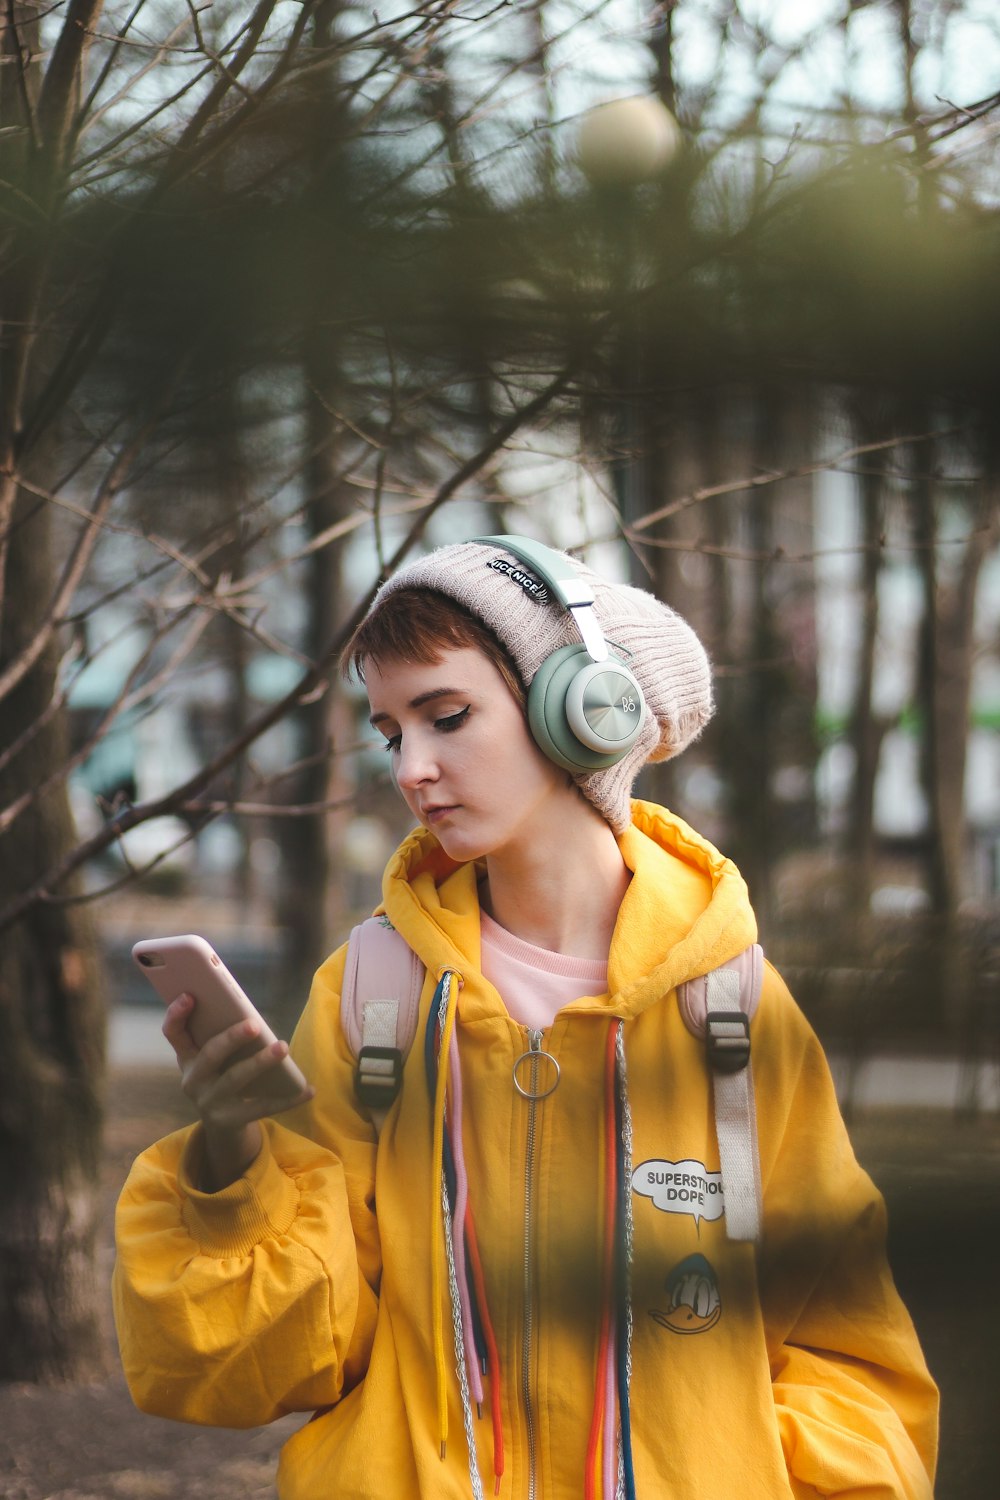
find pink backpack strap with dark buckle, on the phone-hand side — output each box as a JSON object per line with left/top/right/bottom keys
{"left": 340, "top": 917, "right": 424, "bottom": 1131}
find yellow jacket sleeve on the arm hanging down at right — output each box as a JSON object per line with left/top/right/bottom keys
{"left": 754, "top": 972, "right": 937, "bottom": 1500}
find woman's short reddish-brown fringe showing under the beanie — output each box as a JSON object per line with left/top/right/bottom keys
{"left": 340, "top": 587, "right": 528, "bottom": 708}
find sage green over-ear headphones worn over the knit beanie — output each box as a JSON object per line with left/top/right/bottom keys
{"left": 472, "top": 537, "right": 646, "bottom": 774}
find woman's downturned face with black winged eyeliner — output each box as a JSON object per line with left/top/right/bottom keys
{"left": 364, "top": 647, "right": 569, "bottom": 861}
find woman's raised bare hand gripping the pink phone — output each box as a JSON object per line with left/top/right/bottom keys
{"left": 163, "top": 995, "right": 315, "bottom": 1193}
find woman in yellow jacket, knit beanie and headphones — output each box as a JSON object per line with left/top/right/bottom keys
{"left": 115, "top": 539, "right": 937, "bottom": 1500}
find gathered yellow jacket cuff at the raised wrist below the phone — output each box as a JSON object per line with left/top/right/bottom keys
{"left": 177, "top": 1121, "right": 298, "bottom": 1260}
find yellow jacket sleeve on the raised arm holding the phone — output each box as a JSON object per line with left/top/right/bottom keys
{"left": 112, "top": 950, "right": 381, "bottom": 1427}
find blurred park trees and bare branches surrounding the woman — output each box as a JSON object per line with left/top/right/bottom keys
{"left": 0, "top": 0, "right": 1000, "bottom": 1379}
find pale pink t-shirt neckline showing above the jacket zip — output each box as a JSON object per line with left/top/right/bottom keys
{"left": 481, "top": 912, "right": 607, "bottom": 1031}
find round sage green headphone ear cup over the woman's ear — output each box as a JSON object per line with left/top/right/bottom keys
{"left": 528, "top": 645, "right": 646, "bottom": 774}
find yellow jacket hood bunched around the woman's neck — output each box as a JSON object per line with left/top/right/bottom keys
{"left": 381, "top": 801, "right": 757, "bottom": 1019}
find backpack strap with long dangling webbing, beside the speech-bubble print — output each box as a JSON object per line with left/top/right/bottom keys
{"left": 678, "top": 944, "right": 763, "bottom": 1241}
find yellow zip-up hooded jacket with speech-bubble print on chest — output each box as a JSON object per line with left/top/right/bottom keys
{"left": 114, "top": 803, "right": 937, "bottom": 1500}
